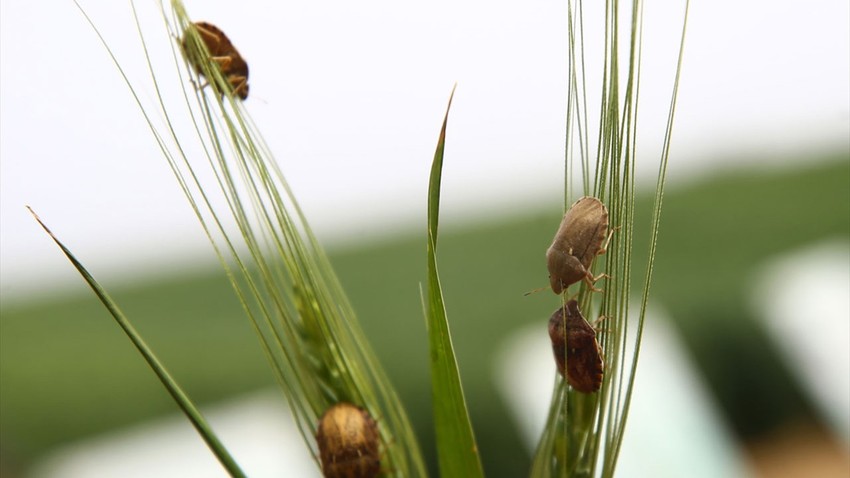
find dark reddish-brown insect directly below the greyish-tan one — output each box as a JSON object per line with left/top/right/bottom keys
{"left": 549, "top": 300, "right": 603, "bottom": 393}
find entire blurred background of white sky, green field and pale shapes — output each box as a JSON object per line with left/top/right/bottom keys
{"left": 0, "top": 0, "right": 850, "bottom": 477}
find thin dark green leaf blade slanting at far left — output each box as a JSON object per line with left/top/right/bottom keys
{"left": 27, "top": 206, "right": 245, "bottom": 477}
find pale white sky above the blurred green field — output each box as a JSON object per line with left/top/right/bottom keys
{"left": 0, "top": 0, "right": 850, "bottom": 298}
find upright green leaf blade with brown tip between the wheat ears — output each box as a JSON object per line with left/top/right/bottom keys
{"left": 426, "top": 89, "right": 484, "bottom": 478}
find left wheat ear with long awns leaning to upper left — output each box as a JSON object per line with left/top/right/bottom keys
{"left": 61, "top": 0, "right": 426, "bottom": 477}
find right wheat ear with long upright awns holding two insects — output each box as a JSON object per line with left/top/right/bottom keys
{"left": 531, "top": 0, "right": 689, "bottom": 477}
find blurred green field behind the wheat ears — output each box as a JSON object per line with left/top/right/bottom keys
{"left": 0, "top": 151, "right": 850, "bottom": 476}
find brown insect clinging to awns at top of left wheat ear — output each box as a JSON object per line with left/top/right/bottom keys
{"left": 182, "top": 22, "right": 248, "bottom": 100}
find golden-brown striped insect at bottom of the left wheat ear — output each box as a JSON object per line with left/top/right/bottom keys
{"left": 316, "top": 402, "right": 381, "bottom": 478}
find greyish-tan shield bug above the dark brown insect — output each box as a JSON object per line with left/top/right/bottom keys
{"left": 546, "top": 196, "right": 611, "bottom": 294}
